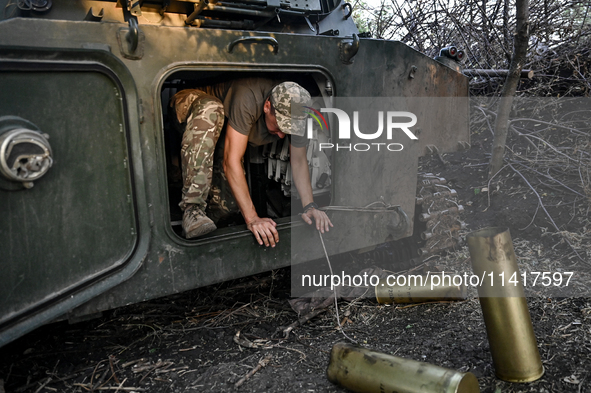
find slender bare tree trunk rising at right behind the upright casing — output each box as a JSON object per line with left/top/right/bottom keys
{"left": 488, "top": 0, "right": 529, "bottom": 178}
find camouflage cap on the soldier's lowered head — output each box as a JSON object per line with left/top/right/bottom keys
{"left": 270, "top": 82, "right": 312, "bottom": 136}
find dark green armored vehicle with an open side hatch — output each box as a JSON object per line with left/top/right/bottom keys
{"left": 0, "top": 0, "right": 469, "bottom": 345}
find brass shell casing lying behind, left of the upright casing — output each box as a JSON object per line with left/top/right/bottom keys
{"left": 375, "top": 275, "right": 466, "bottom": 304}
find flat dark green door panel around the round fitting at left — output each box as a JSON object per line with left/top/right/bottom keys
{"left": 0, "top": 71, "right": 137, "bottom": 322}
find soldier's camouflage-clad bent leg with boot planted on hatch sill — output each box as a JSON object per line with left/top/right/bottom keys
{"left": 179, "top": 91, "right": 224, "bottom": 238}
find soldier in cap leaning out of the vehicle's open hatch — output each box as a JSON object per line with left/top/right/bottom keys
{"left": 171, "top": 78, "right": 333, "bottom": 247}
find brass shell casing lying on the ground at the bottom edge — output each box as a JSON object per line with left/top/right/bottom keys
{"left": 327, "top": 343, "right": 480, "bottom": 393}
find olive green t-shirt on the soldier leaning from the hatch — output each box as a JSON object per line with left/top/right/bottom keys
{"left": 205, "top": 78, "right": 308, "bottom": 147}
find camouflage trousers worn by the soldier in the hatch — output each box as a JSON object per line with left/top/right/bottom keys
{"left": 172, "top": 90, "right": 238, "bottom": 223}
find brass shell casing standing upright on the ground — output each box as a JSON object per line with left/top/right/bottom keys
{"left": 467, "top": 228, "right": 544, "bottom": 382}
